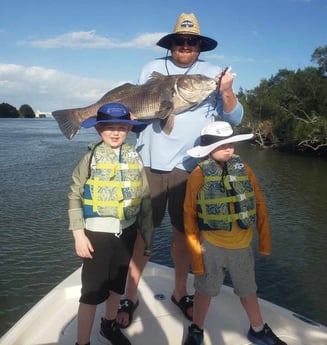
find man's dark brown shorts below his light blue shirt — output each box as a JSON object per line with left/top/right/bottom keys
{"left": 145, "top": 168, "right": 190, "bottom": 232}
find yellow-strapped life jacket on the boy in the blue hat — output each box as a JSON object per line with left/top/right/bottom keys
{"left": 83, "top": 143, "right": 143, "bottom": 220}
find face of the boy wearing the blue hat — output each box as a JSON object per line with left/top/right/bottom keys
{"left": 95, "top": 123, "right": 132, "bottom": 149}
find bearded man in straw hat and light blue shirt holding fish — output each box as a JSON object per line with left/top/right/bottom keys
{"left": 117, "top": 13, "right": 243, "bottom": 328}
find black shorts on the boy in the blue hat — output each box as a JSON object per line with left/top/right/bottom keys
{"left": 79, "top": 224, "right": 137, "bottom": 305}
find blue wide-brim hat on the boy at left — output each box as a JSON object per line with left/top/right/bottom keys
{"left": 81, "top": 103, "right": 147, "bottom": 133}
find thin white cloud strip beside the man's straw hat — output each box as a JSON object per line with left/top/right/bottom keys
{"left": 18, "top": 30, "right": 166, "bottom": 49}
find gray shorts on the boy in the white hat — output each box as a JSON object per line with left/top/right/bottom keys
{"left": 194, "top": 239, "right": 257, "bottom": 297}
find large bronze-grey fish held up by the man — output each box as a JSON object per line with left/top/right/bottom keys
{"left": 52, "top": 72, "right": 217, "bottom": 139}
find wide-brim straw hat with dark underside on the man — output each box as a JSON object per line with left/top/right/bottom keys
{"left": 157, "top": 13, "right": 218, "bottom": 52}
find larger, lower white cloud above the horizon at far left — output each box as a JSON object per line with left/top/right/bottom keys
{"left": 0, "top": 63, "right": 121, "bottom": 112}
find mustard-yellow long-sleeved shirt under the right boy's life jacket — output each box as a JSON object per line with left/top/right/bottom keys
{"left": 184, "top": 163, "right": 271, "bottom": 274}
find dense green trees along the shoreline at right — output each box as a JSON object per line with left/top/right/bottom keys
{"left": 238, "top": 51, "right": 327, "bottom": 154}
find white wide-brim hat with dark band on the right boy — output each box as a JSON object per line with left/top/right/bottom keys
{"left": 187, "top": 121, "right": 253, "bottom": 158}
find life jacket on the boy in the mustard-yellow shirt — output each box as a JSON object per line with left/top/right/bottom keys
{"left": 197, "top": 155, "right": 256, "bottom": 231}
